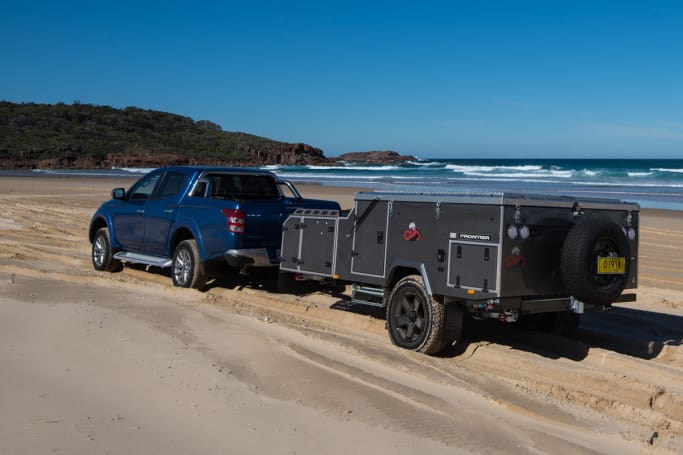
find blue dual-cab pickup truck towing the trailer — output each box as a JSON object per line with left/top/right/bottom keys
{"left": 89, "top": 166, "right": 340, "bottom": 289}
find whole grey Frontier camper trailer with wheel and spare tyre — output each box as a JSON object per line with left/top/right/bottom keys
{"left": 280, "top": 192, "right": 640, "bottom": 354}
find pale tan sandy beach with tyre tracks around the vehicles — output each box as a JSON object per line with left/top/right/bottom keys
{"left": 0, "top": 177, "right": 683, "bottom": 454}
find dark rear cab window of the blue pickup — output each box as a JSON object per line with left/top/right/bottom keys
{"left": 202, "top": 174, "right": 280, "bottom": 199}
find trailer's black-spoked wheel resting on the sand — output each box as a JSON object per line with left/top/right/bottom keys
{"left": 387, "top": 275, "right": 446, "bottom": 354}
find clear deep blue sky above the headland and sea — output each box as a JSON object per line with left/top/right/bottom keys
{"left": 0, "top": 0, "right": 683, "bottom": 158}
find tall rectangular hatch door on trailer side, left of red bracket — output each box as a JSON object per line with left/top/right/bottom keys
{"left": 351, "top": 199, "right": 389, "bottom": 277}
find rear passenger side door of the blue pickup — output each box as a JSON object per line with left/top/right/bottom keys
{"left": 144, "top": 172, "right": 187, "bottom": 256}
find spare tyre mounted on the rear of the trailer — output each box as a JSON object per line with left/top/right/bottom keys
{"left": 560, "top": 221, "right": 631, "bottom": 306}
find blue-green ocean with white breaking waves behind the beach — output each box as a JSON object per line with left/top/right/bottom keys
{"left": 12, "top": 159, "right": 683, "bottom": 210}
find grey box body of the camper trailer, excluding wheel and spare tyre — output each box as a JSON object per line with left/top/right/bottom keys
{"left": 281, "top": 192, "right": 639, "bottom": 311}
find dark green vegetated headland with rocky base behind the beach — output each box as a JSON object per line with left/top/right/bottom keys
{"left": 0, "top": 101, "right": 326, "bottom": 169}
